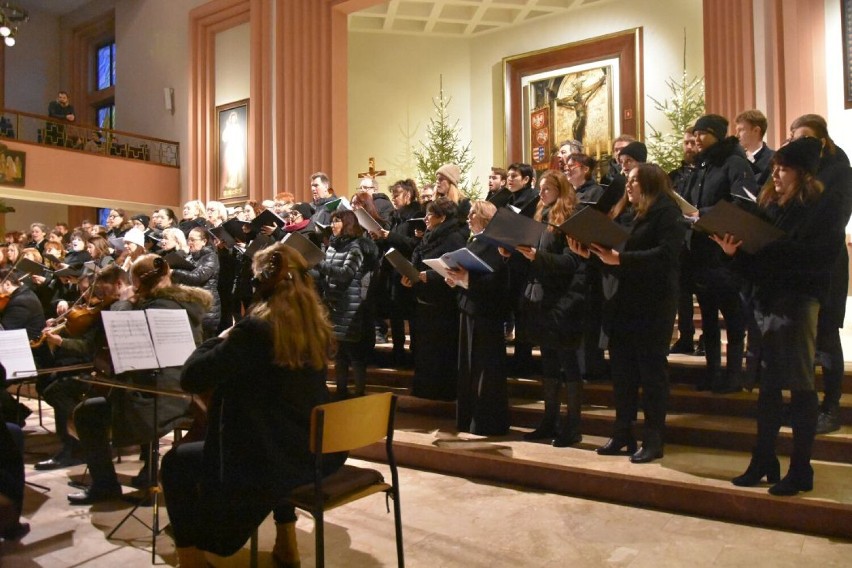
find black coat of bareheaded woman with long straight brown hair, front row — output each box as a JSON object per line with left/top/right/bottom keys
{"left": 602, "top": 195, "right": 684, "bottom": 353}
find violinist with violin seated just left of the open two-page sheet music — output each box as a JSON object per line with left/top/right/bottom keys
{"left": 35, "top": 264, "right": 128, "bottom": 470}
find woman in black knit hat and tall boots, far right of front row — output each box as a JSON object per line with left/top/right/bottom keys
{"left": 713, "top": 137, "right": 845, "bottom": 495}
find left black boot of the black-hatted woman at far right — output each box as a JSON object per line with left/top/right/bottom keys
{"left": 731, "top": 387, "right": 783, "bottom": 487}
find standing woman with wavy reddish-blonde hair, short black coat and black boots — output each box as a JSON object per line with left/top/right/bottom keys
{"left": 510, "top": 170, "right": 586, "bottom": 447}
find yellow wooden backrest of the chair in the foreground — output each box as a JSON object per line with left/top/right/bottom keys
{"left": 311, "top": 392, "right": 393, "bottom": 454}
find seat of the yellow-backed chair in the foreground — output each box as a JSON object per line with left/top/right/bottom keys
{"left": 289, "top": 465, "right": 391, "bottom": 510}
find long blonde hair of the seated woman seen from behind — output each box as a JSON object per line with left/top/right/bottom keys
{"left": 250, "top": 243, "right": 334, "bottom": 370}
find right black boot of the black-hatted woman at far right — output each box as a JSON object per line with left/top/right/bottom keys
{"left": 769, "top": 391, "right": 819, "bottom": 496}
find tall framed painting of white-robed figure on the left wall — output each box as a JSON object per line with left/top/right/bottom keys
{"left": 215, "top": 99, "right": 249, "bottom": 201}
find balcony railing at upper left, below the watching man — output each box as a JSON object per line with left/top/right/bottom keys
{"left": 0, "top": 109, "right": 180, "bottom": 168}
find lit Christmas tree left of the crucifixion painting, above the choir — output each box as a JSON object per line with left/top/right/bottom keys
{"left": 414, "top": 76, "right": 479, "bottom": 199}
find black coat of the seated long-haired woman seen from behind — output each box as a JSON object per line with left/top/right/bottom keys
{"left": 180, "top": 316, "right": 346, "bottom": 555}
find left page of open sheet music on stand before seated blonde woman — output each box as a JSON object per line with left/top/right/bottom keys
{"left": 101, "top": 310, "right": 160, "bottom": 374}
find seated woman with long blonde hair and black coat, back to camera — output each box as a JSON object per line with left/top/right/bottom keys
{"left": 162, "top": 244, "right": 345, "bottom": 568}
